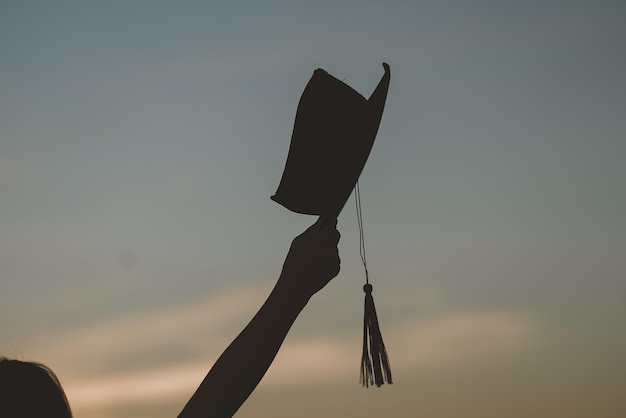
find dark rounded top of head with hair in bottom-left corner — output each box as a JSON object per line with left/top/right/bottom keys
{"left": 0, "top": 357, "right": 72, "bottom": 418}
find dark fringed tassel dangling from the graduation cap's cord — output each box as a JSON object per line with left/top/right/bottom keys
{"left": 359, "top": 283, "right": 393, "bottom": 387}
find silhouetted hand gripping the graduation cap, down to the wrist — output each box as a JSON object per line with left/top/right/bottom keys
{"left": 277, "top": 218, "right": 341, "bottom": 300}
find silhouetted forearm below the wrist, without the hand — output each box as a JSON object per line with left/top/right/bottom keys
{"left": 179, "top": 281, "right": 307, "bottom": 418}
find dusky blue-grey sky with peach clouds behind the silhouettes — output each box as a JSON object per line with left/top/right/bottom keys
{"left": 0, "top": 0, "right": 626, "bottom": 418}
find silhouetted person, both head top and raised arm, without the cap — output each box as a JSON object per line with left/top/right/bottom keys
{"left": 0, "top": 218, "right": 340, "bottom": 418}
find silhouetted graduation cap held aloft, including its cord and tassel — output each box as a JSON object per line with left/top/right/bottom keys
{"left": 271, "top": 63, "right": 392, "bottom": 387}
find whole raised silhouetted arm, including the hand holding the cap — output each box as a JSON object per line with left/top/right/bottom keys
{"left": 179, "top": 219, "right": 339, "bottom": 418}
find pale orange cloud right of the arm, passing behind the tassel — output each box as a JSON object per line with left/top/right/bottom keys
{"left": 264, "top": 311, "right": 538, "bottom": 386}
